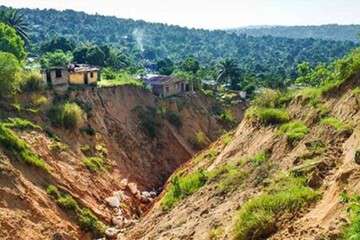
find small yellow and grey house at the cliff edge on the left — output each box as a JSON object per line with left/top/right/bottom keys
{"left": 42, "top": 64, "right": 100, "bottom": 89}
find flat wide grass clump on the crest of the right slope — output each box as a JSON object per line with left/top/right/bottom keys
{"left": 246, "top": 107, "right": 290, "bottom": 125}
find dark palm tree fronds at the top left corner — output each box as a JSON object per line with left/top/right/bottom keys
{"left": 0, "top": 8, "right": 30, "bottom": 43}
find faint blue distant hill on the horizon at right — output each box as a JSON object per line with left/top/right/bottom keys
{"left": 229, "top": 24, "right": 360, "bottom": 42}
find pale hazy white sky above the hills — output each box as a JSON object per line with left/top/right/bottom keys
{"left": 0, "top": 0, "right": 360, "bottom": 29}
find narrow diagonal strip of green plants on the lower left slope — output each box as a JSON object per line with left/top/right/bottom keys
{"left": 47, "top": 185, "right": 106, "bottom": 237}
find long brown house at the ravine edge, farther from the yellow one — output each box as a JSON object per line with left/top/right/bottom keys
{"left": 145, "top": 75, "right": 193, "bottom": 97}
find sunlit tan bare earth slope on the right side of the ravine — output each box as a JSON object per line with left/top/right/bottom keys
{"left": 126, "top": 74, "right": 360, "bottom": 240}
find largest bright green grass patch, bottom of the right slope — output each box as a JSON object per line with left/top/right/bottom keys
{"left": 233, "top": 176, "right": 318, "bottom": 240}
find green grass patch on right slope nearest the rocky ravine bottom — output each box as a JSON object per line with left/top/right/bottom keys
{"left": 161, "top": 170, "right": 208, "bottom": 211}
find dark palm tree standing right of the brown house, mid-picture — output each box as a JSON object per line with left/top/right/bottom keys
{"left": 217, "top": 58, "right": 241, "bottom": 88}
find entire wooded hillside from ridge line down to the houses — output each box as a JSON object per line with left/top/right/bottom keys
{"left": 0, "top": 6, "right": 356, "bottom": 90}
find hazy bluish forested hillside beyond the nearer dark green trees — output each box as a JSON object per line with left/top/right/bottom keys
{"left": 11, "top": 9, "right": 355, "bottom": 83}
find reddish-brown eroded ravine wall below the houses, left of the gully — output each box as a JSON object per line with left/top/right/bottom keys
{"left": 0, "top": 86, "right": 245, "bottom": 240}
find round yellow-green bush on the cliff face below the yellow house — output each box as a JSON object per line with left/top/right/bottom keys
{"left": 48, "top": 103, "right": 85, "bottom": 129}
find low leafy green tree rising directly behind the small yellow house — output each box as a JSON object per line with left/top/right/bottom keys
{"left": 40, "top": 50, "right": 73, "bottom": 68}
